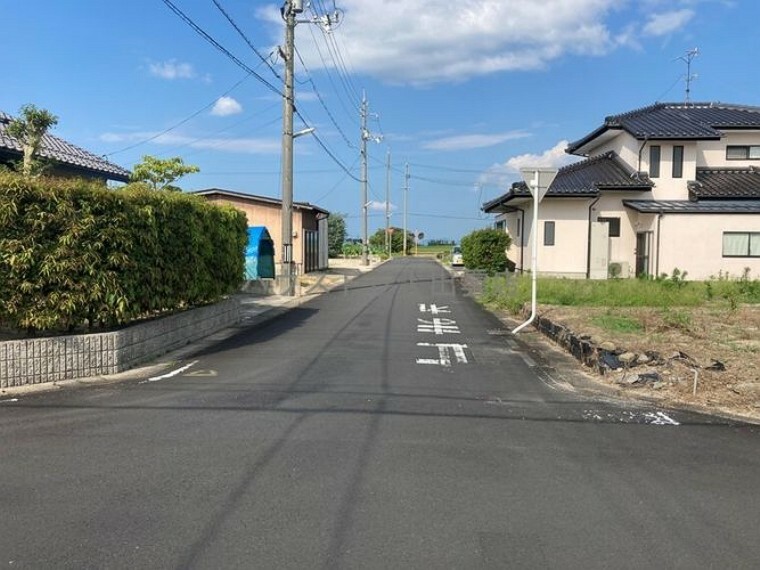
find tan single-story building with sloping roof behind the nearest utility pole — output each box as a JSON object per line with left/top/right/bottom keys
{"left": 190, "top": 188, "right": 330, "bottom": 273}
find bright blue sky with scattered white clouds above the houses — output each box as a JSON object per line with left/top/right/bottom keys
{"left": 0, "top": 0, "right": 760, "bottom": 240}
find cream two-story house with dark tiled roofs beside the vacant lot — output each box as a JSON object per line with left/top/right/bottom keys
{"left": 483, "top": 103, "right": 760, "bottom": 279}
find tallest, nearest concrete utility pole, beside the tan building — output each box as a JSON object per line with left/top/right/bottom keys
{"left": 278, "top": 0, "right": 303, "bottom": 296}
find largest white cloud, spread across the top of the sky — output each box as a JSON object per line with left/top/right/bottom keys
{"left": 258, "top": 0, "right": 621, "bottom": 85}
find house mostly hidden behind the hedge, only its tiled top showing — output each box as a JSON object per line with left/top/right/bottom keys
{"left": 0, "top": 111, "right": 130, "bottom": 182}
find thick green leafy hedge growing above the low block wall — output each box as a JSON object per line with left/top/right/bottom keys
{"left": 0, "top": 172, "right": 247, "bottom": 332}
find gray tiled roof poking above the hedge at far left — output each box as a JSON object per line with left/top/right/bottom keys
{"left": 0, "top": 111, "right": 130, "bottom": 182}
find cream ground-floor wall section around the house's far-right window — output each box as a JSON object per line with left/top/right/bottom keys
{"left": 658, "top": 214, "right": 760, "bottom": 280}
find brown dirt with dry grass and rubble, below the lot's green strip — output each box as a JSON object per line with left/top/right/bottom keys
{"left": 524, "top": 304, "right": 760, "bottom": 420}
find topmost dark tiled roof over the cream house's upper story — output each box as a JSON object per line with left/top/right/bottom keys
{"left": 567, "top": 103, "right": 760, "bottom": 154}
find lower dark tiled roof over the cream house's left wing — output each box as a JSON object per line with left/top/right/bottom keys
{"left": 483, "top": 152, "right": 653, "bottom": 213}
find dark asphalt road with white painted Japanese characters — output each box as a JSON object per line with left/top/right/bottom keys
{"left": 0, "top": 260, "right": 760, "bottom": 569}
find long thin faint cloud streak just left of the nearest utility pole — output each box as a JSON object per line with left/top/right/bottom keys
{"left": 100, "top": 132, "right": 282, "bottom": 154}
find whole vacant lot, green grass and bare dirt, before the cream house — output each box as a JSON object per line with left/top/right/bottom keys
{"left": 480, "top": 270, "right": 760, "bottom": 419}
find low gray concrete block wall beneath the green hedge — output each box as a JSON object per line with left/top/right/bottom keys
{"left": 0, "top": 298, "right": 241, "bottom": 388}
